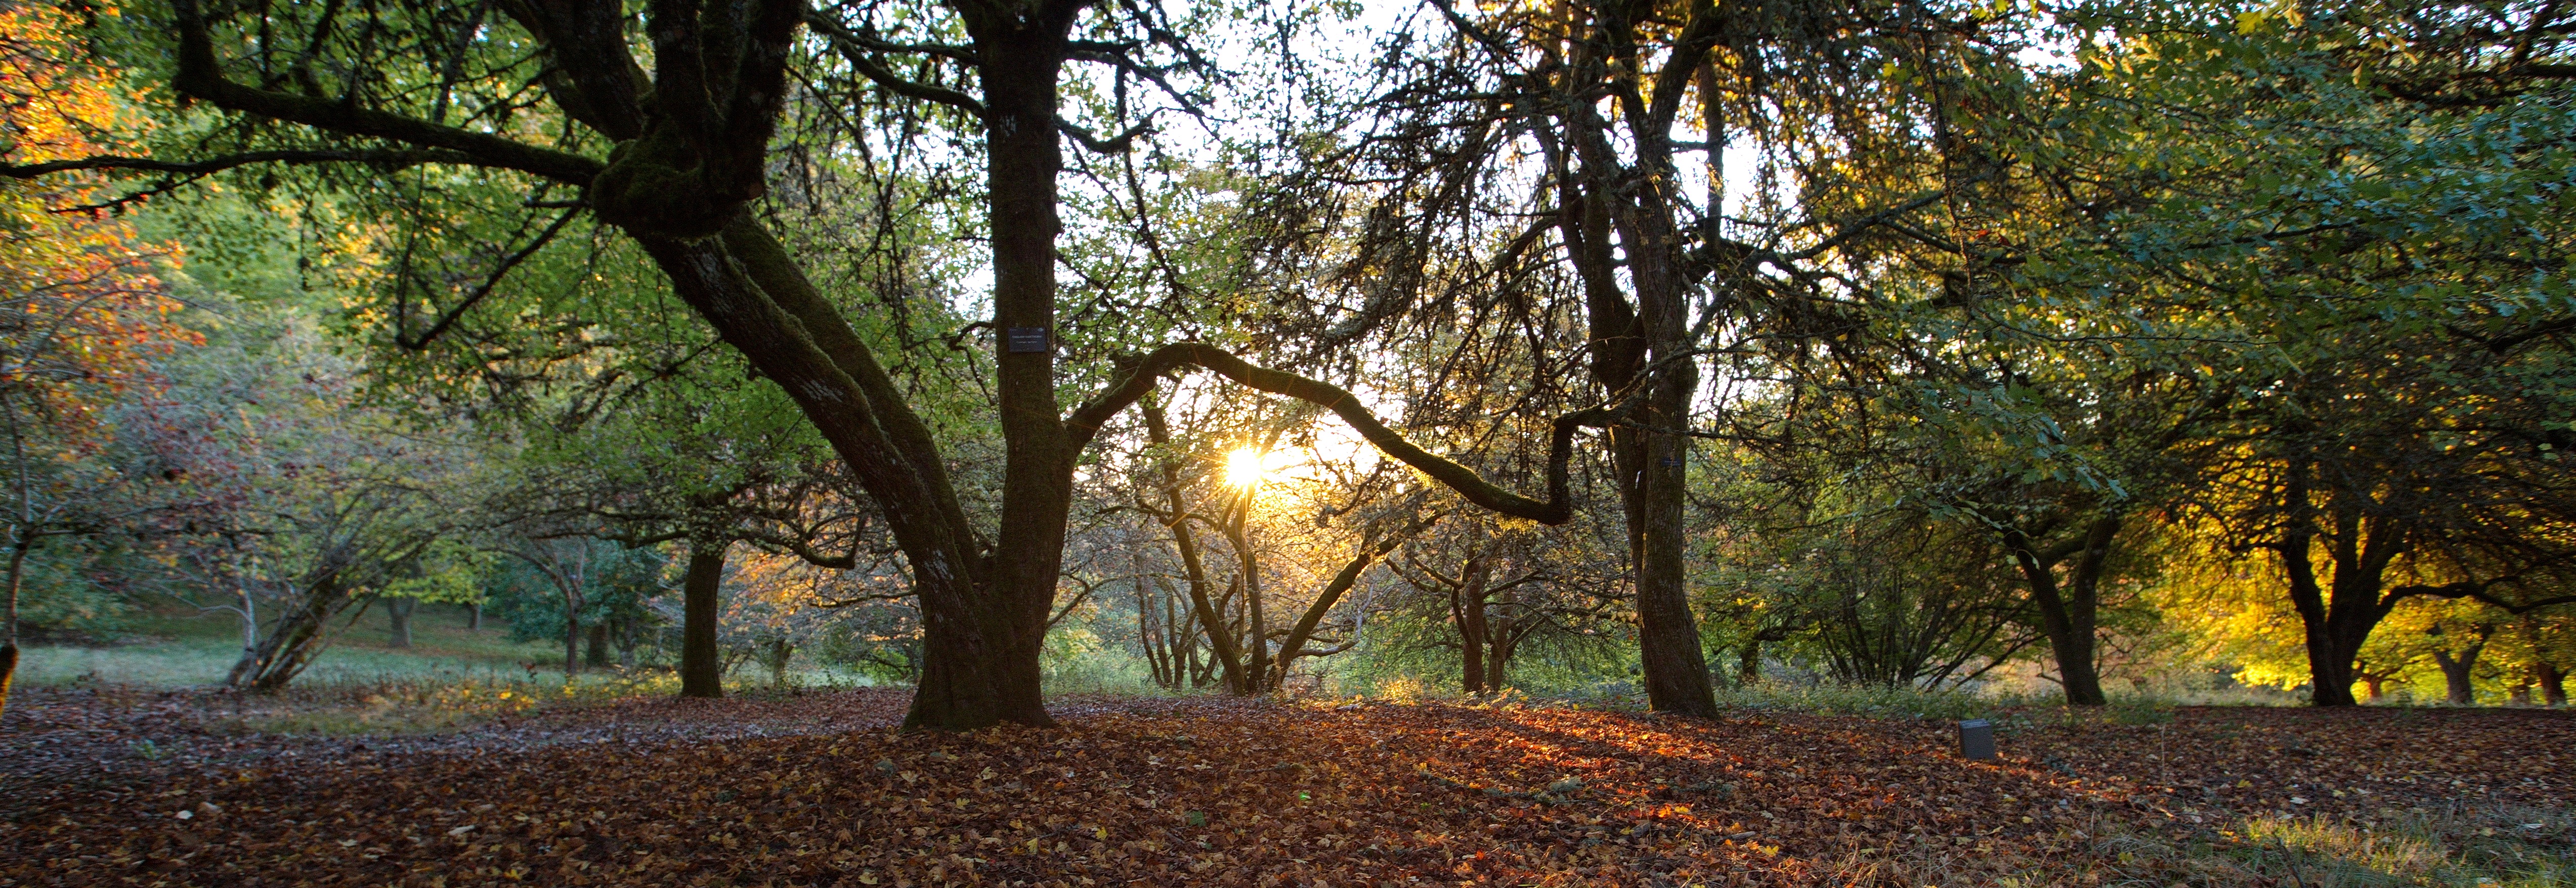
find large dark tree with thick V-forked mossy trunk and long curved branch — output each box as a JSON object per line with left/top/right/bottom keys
{"left": 30, "top": 0, "right": 1648, "bottom": 728}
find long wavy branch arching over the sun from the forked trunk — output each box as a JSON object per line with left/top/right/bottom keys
{"left": 1064, "top": 342, "right": 1610, "bottom": 525}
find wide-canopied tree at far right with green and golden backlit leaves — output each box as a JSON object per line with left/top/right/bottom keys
{"left": 1963, "top": 5, "right": 2576, "bottom": 705}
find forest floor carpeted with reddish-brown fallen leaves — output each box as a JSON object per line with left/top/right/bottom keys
{"left": 0, "top": 687, "right": 2576, "bottom": 888}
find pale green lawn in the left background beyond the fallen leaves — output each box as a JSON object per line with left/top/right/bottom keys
{"left": 18, "top": 605, "right": 564, "bottom": 687}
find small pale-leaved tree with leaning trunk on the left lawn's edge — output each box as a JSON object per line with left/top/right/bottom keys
{"left": 126, "top": 318, "right": 477, "bottom": 690}
